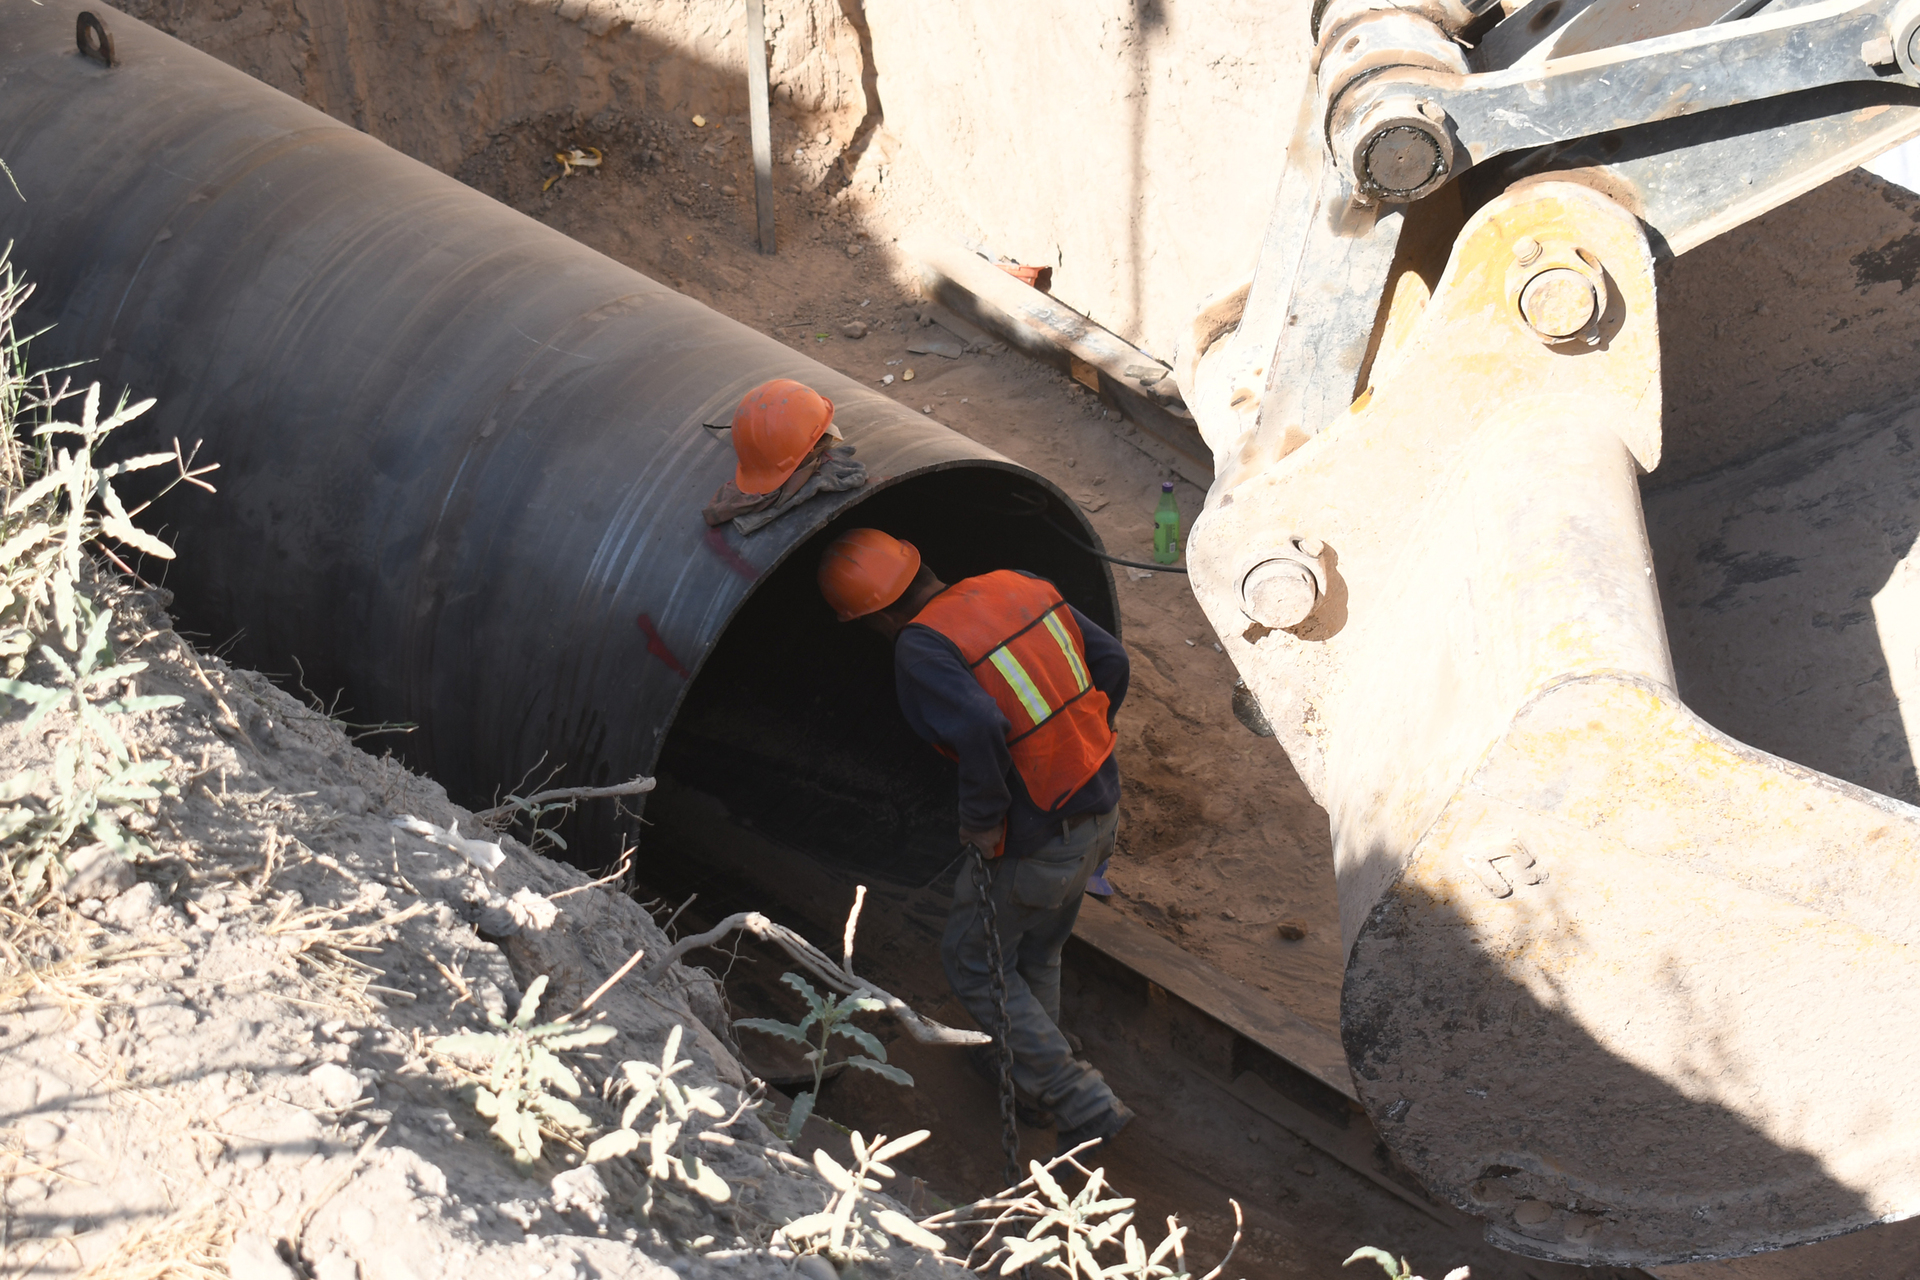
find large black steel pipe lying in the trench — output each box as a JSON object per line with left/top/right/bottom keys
{"left": 0, "top": 0, "right": 1116, "bottom": 879}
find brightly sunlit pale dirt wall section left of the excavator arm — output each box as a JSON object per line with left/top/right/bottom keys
{"left": 866, "top": 0, "right": 1308, "bottom": 359}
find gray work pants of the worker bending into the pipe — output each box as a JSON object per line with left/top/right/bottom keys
{"left": 941, "top": 810, "right": 1119, "bottom": 1128}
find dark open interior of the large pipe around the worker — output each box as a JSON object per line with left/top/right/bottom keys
{"left": 639, "top": 464, "right": 1117, "bottom": 885}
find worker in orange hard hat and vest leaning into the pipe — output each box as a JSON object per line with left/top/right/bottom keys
{"left": 820, "top": 530, "right": 1133, "bottom": 1151}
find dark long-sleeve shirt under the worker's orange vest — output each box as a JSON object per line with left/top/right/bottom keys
{"left": 893, "top": 579, "right": 1131, "bottom": 858}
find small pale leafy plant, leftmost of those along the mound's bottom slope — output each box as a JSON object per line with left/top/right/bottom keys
{"left": 434, "top": 975, "right": 618, "bottom": 1165}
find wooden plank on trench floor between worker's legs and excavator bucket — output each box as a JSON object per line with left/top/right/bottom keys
{"left": 1073, "top": 902, "right": 1359, "bottom": 1102}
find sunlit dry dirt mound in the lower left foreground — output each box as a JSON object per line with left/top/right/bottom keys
{"left": 0, "top": 587, "right": 933, "bottom": 1280}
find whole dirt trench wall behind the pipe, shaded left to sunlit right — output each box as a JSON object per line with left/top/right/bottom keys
{"left": 113, "top": 0, "right": 1308, "bottom": 359}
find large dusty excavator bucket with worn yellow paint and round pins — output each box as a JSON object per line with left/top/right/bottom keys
{"left": 1181, "top": 6, "right": 1920, "bottom": 1265}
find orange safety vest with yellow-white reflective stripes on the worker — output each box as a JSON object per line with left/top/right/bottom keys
{"left": 914, "top": 568, "right": 1114, "bottom": 812}
